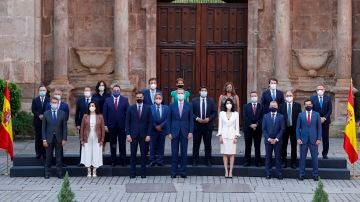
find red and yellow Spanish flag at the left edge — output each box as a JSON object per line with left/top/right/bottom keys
{"left": 0, "top": 83, "right": 14, "bottom": 160}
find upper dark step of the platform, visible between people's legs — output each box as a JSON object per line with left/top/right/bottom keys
{"left": 13, "top": 154, "right": 347, "bottom": 169}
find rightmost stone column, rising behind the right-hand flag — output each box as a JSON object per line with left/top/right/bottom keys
{"left": 331, "top": 0, "right": 356, "bottom": 134}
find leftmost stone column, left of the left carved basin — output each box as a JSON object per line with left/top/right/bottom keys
{"left": 49, "top": 0, "right": 73, "bottom": 102}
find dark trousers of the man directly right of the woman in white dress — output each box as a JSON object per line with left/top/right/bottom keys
{"left": 244, "top": 130, "right": 262, "bottom": 163}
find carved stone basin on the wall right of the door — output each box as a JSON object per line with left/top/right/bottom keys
{"left": 293, "top": 49, "right": 333, "bottom": 77}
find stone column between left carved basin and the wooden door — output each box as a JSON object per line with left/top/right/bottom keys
{"left": 114, "top": 0, "right": 134, "bottom": 93}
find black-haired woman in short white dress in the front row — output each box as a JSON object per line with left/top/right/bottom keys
{"left": 216, "top": 98, "right": 240, "bottom": 178}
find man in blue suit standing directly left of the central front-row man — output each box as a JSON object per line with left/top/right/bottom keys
{"left": 150, "top": 93, "right": 169, "bottom": 166}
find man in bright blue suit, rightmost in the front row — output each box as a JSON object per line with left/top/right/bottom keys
{"left": 296, "top": 100, "right": 322, "bottom": 181}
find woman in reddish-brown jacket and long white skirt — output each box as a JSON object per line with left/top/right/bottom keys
{"left": 80, "top": 102, "right": 105, "bottom": 177}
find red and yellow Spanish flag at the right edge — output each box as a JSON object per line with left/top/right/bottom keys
{"left": 344, "top": 85, "right": 358, "bottom": 164}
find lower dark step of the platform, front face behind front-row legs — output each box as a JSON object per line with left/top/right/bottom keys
{"left": 10, "top": 165, "right": 350, "bottom": 180}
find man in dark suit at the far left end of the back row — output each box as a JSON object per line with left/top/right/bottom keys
{"left": 31, "top": 85, "right": 50, "bottom": 160}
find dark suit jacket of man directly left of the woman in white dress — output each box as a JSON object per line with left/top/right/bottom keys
{"left": 191, "top": 97, "right": 217, "bottom": 130}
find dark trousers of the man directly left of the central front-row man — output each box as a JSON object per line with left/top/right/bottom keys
{"left": 150, "top": 132, "right": 165, "bottom": 163}
